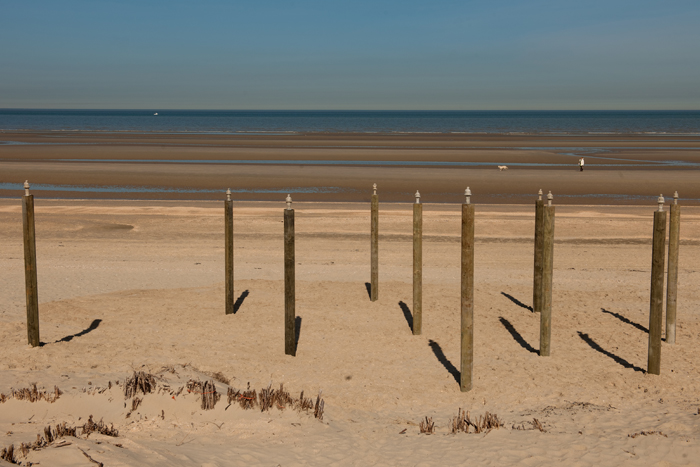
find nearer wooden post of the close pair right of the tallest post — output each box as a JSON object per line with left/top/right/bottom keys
{"left": 540, "top": 191, "right": 554, "bottom": 357}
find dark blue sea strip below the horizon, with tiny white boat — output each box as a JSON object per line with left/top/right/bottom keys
{"left": 0, "top": 109, "right": 700, "bottom": 135}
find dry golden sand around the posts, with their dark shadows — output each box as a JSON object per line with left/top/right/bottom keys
{"left": 0, "top": 199, "right": 700, "bottom": 466}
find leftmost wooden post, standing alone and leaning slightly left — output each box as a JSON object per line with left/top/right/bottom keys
{"left": 22, "top": 181, "right": 41, "bottom": 347}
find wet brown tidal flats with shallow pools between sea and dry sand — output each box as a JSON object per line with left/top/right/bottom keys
{"left": 0, "top": 132, "right": 700, "bottom": 205}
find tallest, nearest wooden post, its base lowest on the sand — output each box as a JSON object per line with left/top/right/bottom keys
{"left": 459, "top": 187, "right": 474, "bottom": 392}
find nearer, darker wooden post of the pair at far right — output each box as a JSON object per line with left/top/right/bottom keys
{"left": 647, "top": 195, "right": 666, "bottom": 375}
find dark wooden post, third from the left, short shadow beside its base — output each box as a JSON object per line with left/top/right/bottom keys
{"left": 284, "top": 195, "right": 296, "bottom": 356}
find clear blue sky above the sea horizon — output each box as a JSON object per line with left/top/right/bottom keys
{"left": 0, "top": 0, "right": 700, "bottom": 110}
